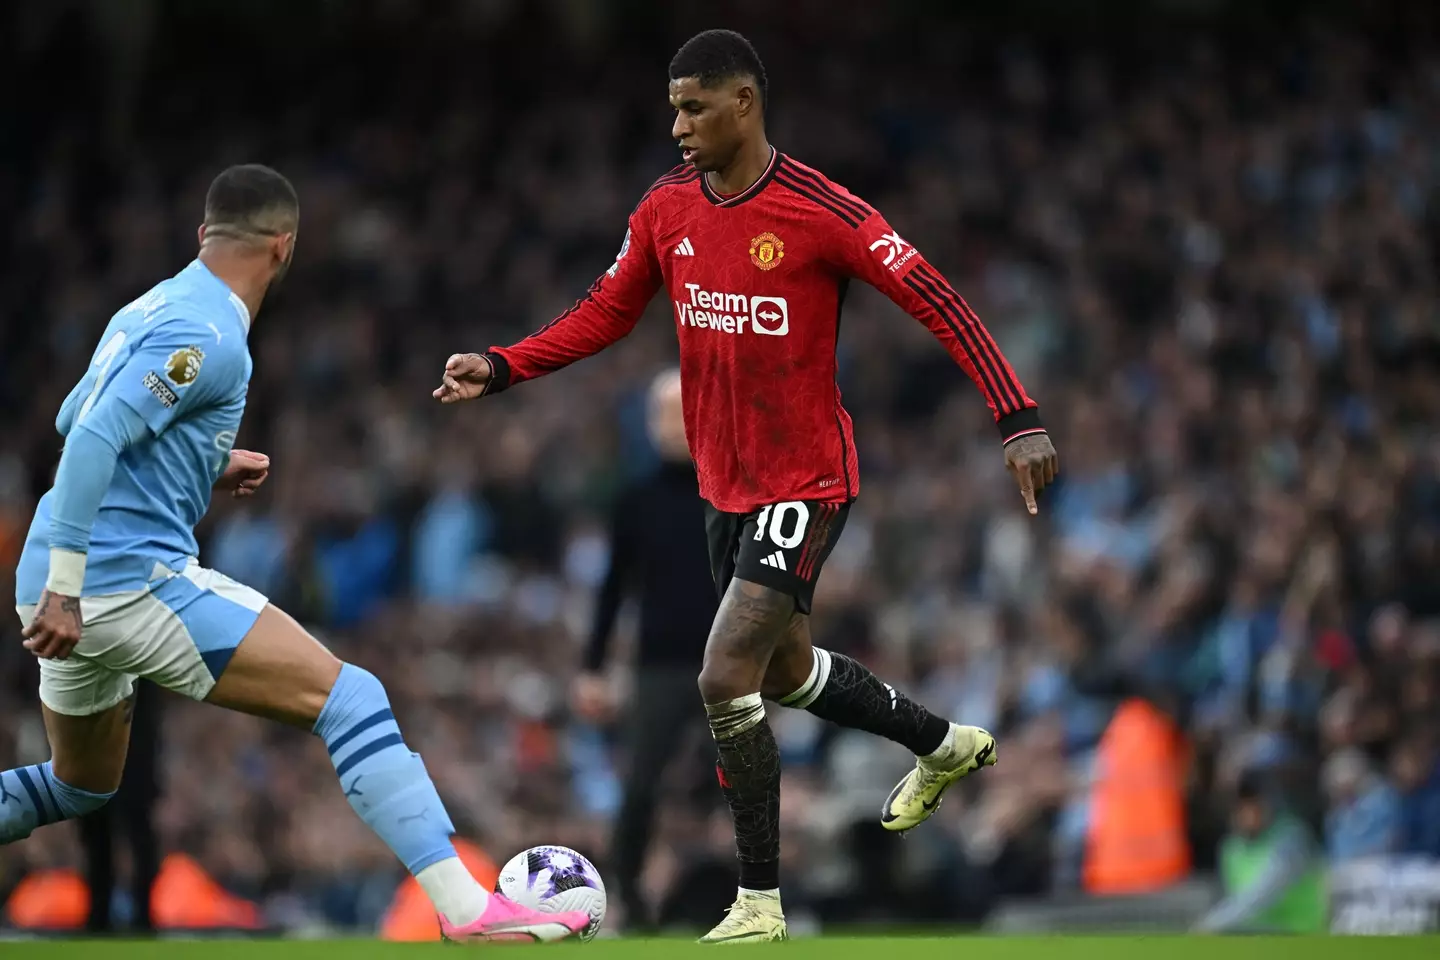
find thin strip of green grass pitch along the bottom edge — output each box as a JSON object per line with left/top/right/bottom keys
{"left": 0, "top": 936, "right": 1440, "bottom": 960}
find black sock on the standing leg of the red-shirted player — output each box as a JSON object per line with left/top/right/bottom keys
{"left": 706, "top": 694, "right": 780, "bottom": 889}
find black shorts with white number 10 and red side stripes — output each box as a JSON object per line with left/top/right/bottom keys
{"left": 706, "top": 501, "right": 850, "bottom": 613}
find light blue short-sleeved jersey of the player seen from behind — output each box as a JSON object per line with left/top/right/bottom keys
{"left": 16, "top": 261, "right": 251, "bottom": 606}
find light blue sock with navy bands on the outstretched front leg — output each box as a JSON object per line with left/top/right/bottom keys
{"left": 315, "top": 664, "right": 455, "bottom": 874}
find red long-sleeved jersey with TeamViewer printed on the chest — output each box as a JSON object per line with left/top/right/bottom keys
{"left": 487, "top": 151, "right": 1044, "bottom": 512}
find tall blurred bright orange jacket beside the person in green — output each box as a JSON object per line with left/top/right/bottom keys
{"left": 1083, "top": 699, "right": 1189, "bottom": 895}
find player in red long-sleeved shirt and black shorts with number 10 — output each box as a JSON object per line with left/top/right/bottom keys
{"left": 435, "top": 30, "right": 1058, "bottom": 943}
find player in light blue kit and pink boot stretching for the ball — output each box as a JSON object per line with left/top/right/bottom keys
{"left": 0, "top": 164, "right": 589, "bottom": 941}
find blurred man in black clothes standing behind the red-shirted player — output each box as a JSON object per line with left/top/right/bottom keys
{"left": 575, "top": 370, "right": 717, "bottom": 928}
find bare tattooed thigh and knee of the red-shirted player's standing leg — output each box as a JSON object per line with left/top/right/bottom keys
{"left": 700, "top": 579, "right": 795, "bottom": 702}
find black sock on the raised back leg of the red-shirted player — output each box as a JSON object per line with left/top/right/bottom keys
{"left": 780, "top": 646, "right": 950, "bottom": 757}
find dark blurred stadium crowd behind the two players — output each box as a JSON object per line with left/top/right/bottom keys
{"left": 0, "top": 0, "right": 1440, "bottom": 934}
